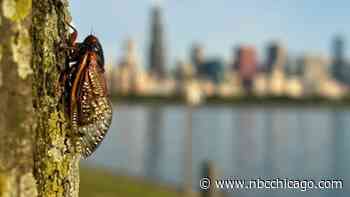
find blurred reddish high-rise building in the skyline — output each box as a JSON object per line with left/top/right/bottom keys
{"left": 233, "top": 46, "right": 257, "bottom": 92}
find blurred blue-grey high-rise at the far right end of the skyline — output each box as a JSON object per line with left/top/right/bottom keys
{"left": 332, "top": 35, "right": 346, "bottom": 81}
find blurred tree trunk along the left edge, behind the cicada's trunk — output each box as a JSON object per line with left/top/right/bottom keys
{"left": 0, "top": 0, "right": 37, "bottom": 197}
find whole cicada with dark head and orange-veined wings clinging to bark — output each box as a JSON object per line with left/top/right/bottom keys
{"left": 60, "top": 24, "right": 112, "bottom": 158}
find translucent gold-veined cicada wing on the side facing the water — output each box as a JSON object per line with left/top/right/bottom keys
{"left": 78, "top": 53, "right": 112, "bottom": 158}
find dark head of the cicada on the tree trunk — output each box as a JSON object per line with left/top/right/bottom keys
{"left": 82, "top": 35, "right": 104, "bottom": 69}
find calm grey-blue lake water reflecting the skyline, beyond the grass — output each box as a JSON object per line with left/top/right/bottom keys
{"left": 84, "top": 104, "right": 350, "bottom": 197}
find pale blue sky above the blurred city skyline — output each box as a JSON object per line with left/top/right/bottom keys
{"left": 70, "top": 0, "right": 350, "bottom": 68}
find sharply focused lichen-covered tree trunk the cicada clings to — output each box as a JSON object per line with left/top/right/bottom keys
{"left": 32, "top": 0, "right": 79, "bottom": 197}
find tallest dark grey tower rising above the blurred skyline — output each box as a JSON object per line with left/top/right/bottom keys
{"left": 149, "top": 4, "right": 165, "bottom": 79}
